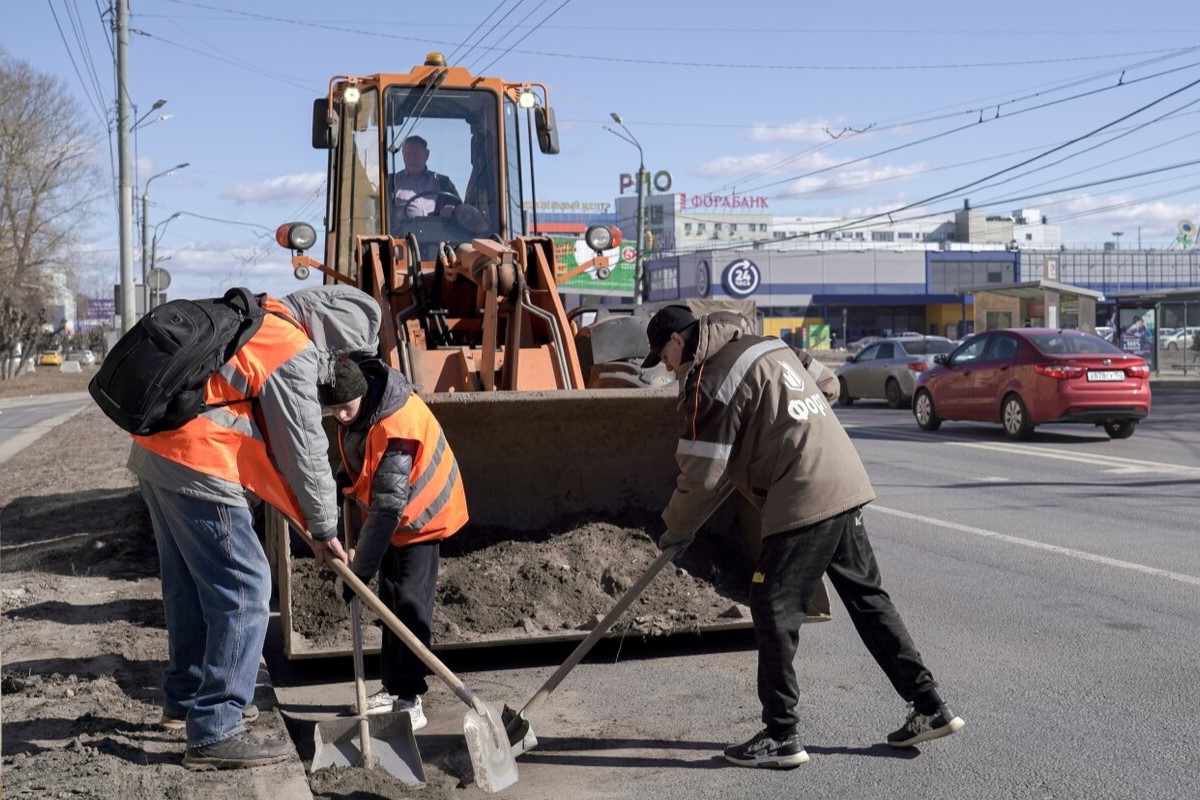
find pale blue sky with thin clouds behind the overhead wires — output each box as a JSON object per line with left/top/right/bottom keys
{"left": 9, "top": 0, "right": 1200, "bottom": 302}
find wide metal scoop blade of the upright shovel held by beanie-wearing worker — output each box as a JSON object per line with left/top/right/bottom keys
{"left": 310, "top": 714, "right": 425, "bottom": 787}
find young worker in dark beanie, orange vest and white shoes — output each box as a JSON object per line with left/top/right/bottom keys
{"left": 319, "top": 359, "right": 467, "bottom": 730}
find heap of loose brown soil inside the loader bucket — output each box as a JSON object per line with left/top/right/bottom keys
{"left": 290, "top": 519, "right": 750, "bottom": 650}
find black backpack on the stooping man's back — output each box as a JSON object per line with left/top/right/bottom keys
{"left": 88, "top": 288, "right": 265, "bottom": 435}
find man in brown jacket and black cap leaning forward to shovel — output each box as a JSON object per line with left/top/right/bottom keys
{"left": 642, "top": 306, "right": 964, "bottom": 769}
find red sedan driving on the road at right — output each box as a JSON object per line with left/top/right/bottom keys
{"left": 912, "top": 327, "right": 1150, "bottom": 439}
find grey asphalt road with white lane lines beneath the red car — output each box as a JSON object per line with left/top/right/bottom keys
{"left": 272, "top": 387, "right": 1200, "bottom": 800}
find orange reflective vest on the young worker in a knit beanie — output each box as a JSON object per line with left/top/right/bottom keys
{"left": 337, "top": 395, "right": 467, "bottom": 547}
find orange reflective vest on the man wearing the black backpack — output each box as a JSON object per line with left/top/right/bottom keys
{"left": 133, "top": 297, "right": 311, "bottom": 522}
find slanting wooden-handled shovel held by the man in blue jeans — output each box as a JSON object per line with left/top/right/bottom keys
{"left": 292, "top": 521, "right": 517, "bottom": 794}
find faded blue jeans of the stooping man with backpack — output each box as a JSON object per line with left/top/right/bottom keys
{"left": 139, "top": 481, "right": 271, "bottom": 747}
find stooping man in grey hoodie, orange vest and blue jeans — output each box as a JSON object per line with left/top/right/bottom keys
{"left": 123, "top": 285, "right": 382, "bottom": 769}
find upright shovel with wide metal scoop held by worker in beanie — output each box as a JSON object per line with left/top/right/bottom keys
{"left": 310, "top": 509, "right": 425, "bottom": 786}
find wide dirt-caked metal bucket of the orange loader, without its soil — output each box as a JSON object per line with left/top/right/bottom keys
{"left": 269, "top": 386, "right": 829, "bottom": 658}
